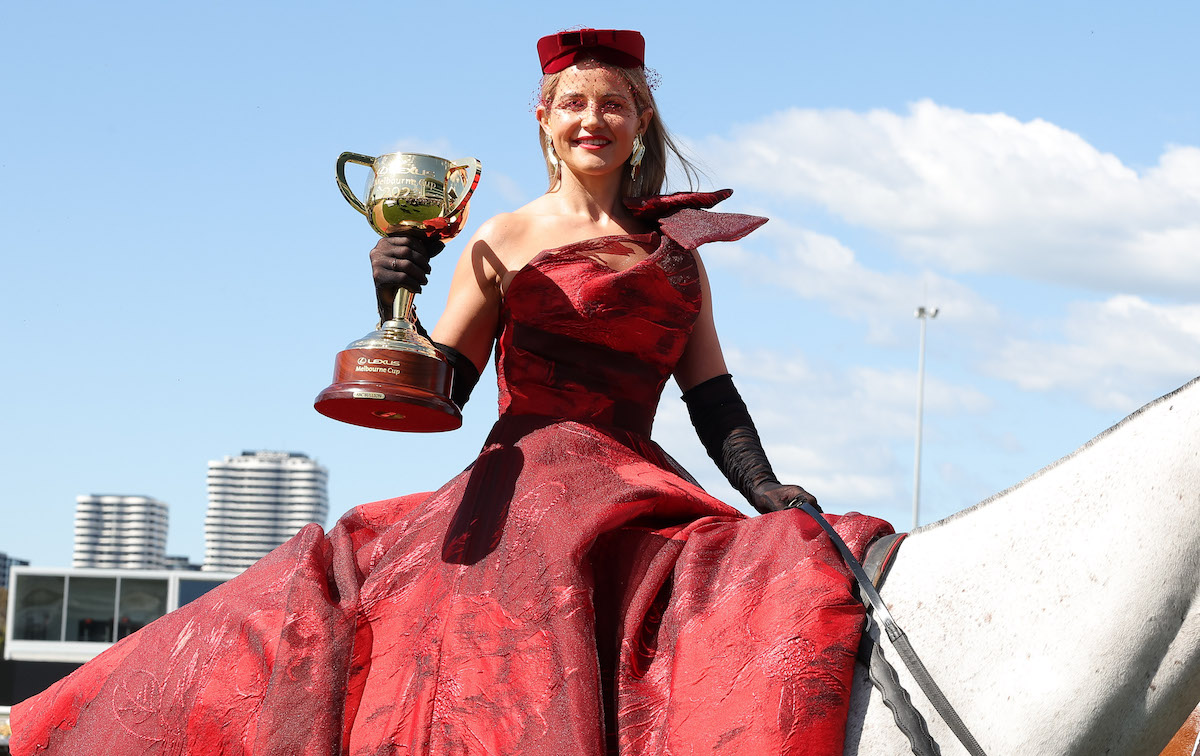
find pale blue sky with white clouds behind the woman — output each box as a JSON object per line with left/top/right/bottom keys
{"left": 0, "top": 1, "right": 1200, "bottom": 565}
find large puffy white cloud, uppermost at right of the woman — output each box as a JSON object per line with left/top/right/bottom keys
{"left": 695, "top": 100, "right": 1200, "bottom": 296}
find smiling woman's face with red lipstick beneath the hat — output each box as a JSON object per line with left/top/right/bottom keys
{"left": 538, "top": 64, "right": 654, "bottom": 182}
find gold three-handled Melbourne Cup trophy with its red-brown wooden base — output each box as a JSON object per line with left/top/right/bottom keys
{"left": 313, "top": 152, "right": 481, "bottom": 432}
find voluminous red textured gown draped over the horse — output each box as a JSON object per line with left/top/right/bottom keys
{"left": 11, "top": 192, "right": 890, "bottom": 756}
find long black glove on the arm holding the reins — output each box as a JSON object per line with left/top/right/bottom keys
{"left": 683, "top": 373, "right": 820, "bottom": 514}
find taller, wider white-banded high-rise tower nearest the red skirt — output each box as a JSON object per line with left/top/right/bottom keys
{"left": 204, "top": 451, "right": 329, "bottom": 572}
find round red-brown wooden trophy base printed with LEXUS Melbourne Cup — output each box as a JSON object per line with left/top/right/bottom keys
{"left": 313, "top": 331, "right": 462, "bottom": 433}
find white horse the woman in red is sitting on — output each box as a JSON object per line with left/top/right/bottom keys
{"left": 845, "top": 378, "right": 1200, "bottom": 756}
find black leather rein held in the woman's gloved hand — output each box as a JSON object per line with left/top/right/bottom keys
{"left": 792, "top": 499, "right": 986, "bottom": 756}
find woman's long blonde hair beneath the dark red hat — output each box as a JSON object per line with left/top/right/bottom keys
{"left": 538, "top": 59, "right": 700, "bottom": 197}
